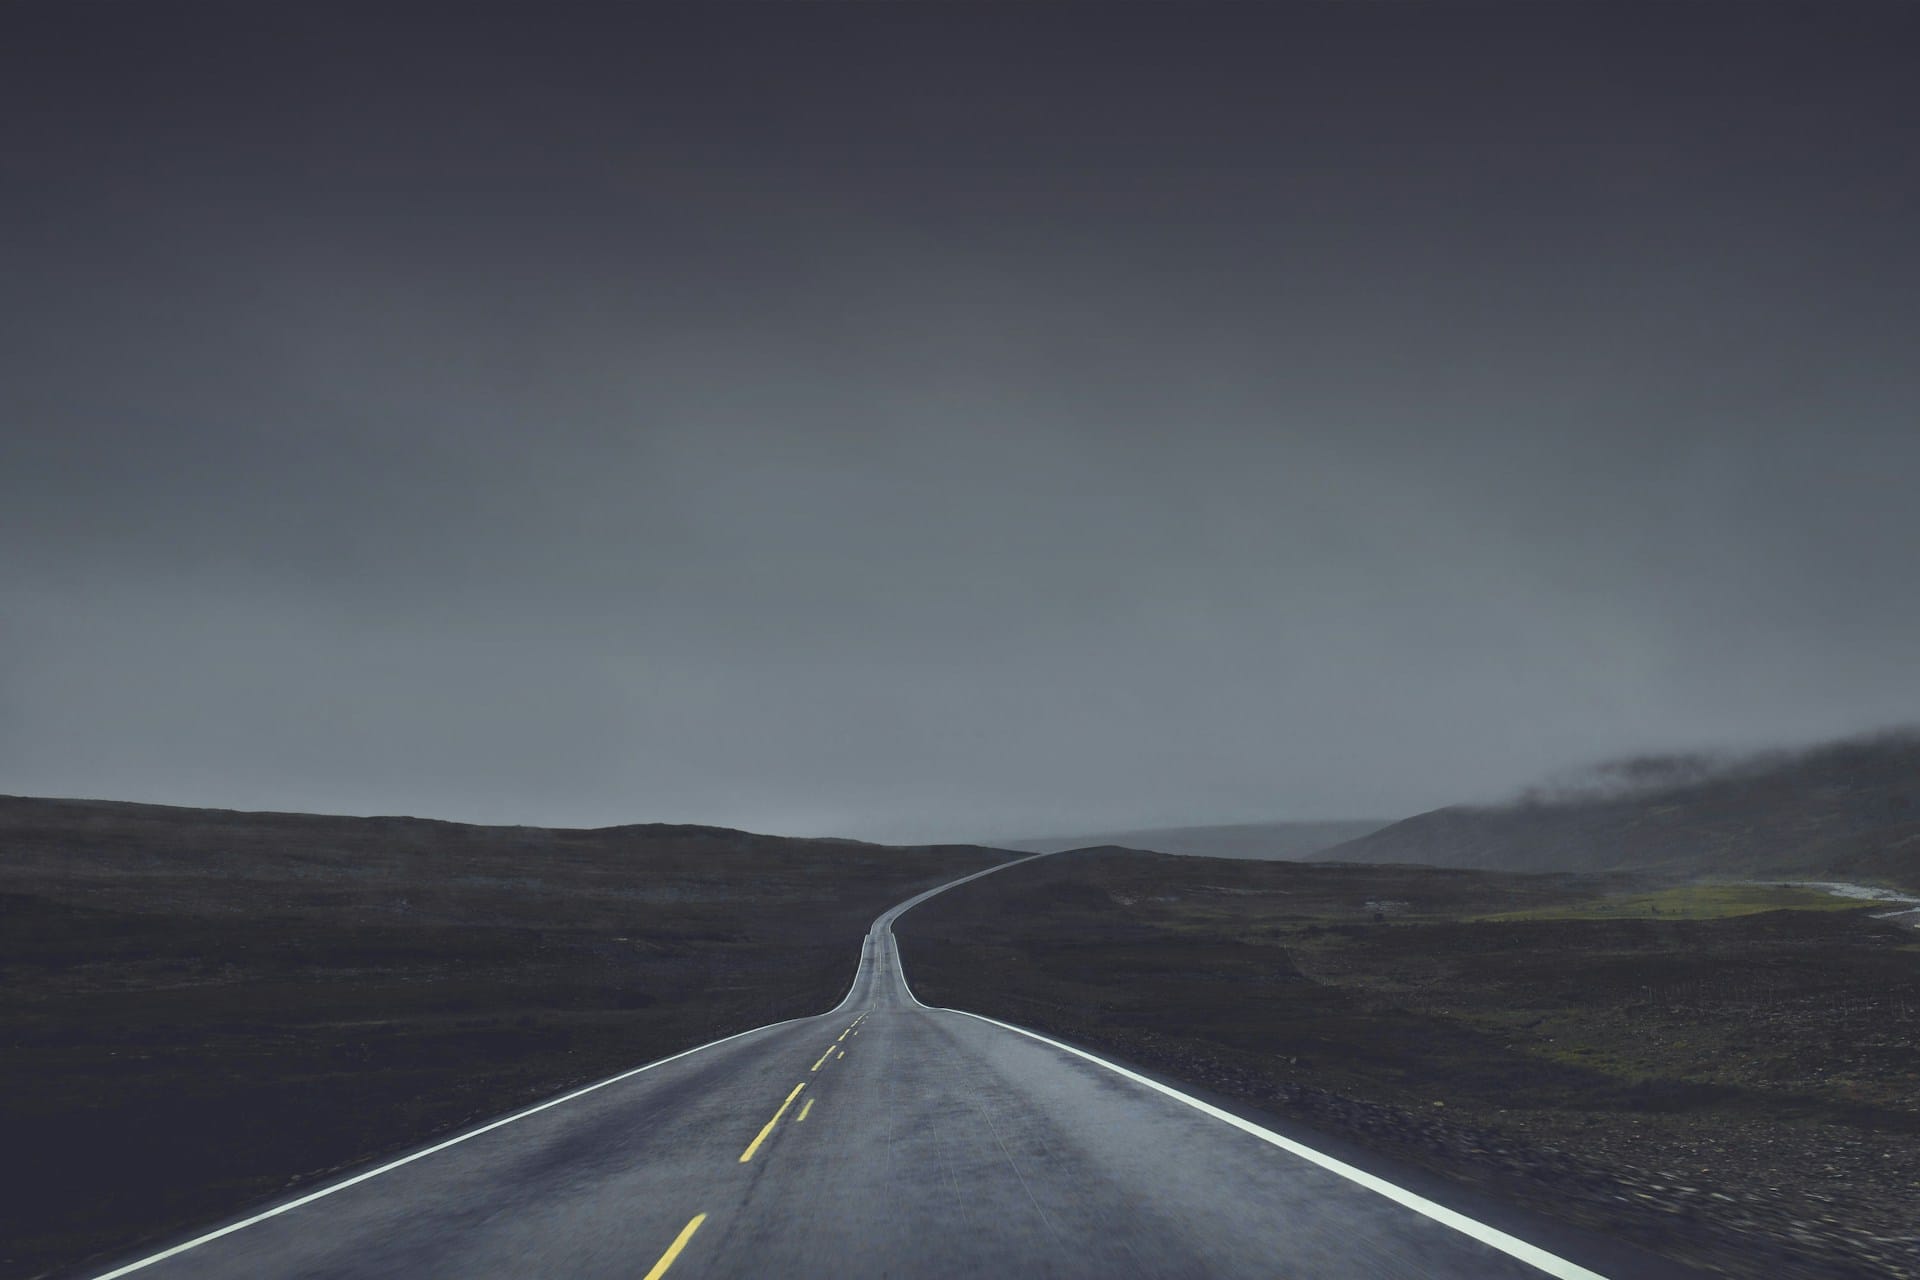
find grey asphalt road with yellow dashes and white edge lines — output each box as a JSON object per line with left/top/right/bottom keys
{"left": 90, "top": 864, "right": 1681, "bottom": 1280}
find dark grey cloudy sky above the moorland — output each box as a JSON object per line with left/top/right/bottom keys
{"left": 0, "top": 0, "right": 1920, "bottom": 839}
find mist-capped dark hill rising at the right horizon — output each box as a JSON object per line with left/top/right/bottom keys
{"left": 1317, "top": 731, "right": 1920, "bottom": 889}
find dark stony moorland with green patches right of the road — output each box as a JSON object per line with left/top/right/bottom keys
{"left": 897, "top": 850, "right": 1920, "bottom": 1278}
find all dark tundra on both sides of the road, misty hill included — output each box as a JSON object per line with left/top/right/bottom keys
{"left": 0, "top": 735, "right": 1920, "bottom": 1280}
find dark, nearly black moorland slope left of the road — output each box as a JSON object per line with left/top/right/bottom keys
{"left": 0, "top": 798, "right": 1004, "bottom": 1276}
